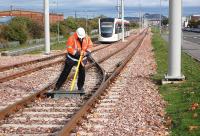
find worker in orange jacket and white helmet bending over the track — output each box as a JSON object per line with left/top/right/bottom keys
{"left": 54, "top": 27, "right": 93, "bottom": 91}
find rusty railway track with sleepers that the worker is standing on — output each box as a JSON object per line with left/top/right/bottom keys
{"left": 0, "top": 29, "right": 147, "bottom": 135}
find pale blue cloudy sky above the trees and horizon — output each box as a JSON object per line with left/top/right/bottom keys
{"left": 0, "top": 0, "right": 200, "bottom": 16}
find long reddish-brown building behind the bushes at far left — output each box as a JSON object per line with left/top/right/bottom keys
{"left": 0, "top": 10, "right": 64, "bottom": 24}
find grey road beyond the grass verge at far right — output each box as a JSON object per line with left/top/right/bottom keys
{"left": 162, "top": 32, "right": 200, "bottom": 61}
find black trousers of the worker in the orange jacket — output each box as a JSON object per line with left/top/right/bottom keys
{"left": 55, "top": 57, "right": 85, "bottom": 90}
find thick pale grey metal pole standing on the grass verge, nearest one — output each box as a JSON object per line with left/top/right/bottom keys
{"left": 165, "top": 0, "right": 185, "bottom": 80}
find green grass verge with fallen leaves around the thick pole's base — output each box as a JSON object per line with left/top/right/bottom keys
{"left": 152, "top": 30, "right": 200, "bottom": 136}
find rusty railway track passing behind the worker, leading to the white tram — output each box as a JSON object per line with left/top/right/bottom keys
{"left": 0, "top": 44, "right": 111, "bottom": 83}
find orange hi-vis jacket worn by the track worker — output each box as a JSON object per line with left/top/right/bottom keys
{"left": 66, "top": 32, "right": 93, "bottom": 55}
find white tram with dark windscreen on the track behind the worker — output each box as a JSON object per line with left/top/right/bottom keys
{"left": 98, "top": 18, "right": 130, "bottom": 43}
